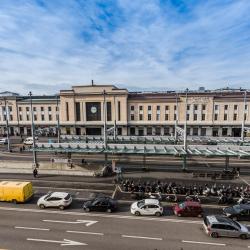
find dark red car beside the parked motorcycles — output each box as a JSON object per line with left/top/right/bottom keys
{"left": 173, "top": 201, "right": 203, "bottom": 218}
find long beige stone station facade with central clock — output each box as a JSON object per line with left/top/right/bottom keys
{"left": 0, "top": 85, "right": 250, "bottom": 137}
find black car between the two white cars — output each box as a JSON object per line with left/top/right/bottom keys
{"left": 83, "top": 197, "right": 117, "bottom": 213}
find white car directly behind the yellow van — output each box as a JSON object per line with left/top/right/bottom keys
{"left": 37, "top": 192, "right": 72, "bottom": 210}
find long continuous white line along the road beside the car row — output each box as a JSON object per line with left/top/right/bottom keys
{"left": 0, "top": 207, "right": 203, "bottom": 225}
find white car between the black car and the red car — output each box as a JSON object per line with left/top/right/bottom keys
{"left": 130, "top": 199, "right": 163, "bottom": 216}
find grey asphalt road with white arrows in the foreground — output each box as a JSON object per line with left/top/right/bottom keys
{"left": 0, "top": 203, "right": 250, "bottom": 250}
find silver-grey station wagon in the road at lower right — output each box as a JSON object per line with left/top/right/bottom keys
{"left": 203, "top": 215, "right": 250, "bottom": 239}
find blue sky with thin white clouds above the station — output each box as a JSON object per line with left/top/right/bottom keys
{"left": 0, "top": 0, "right": 250, "bottom": 94}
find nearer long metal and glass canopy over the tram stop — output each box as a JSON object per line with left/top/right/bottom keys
{"left": 28, "top": 143, "right": 250, "bottom": 158}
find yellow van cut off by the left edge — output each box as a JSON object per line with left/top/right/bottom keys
{"left": 0, "top": 181, "right": 34, "bottom": 203}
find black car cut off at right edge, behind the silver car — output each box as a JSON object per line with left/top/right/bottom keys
{"left": 223, "top": 204, "right": 250, "bottom": 220}
